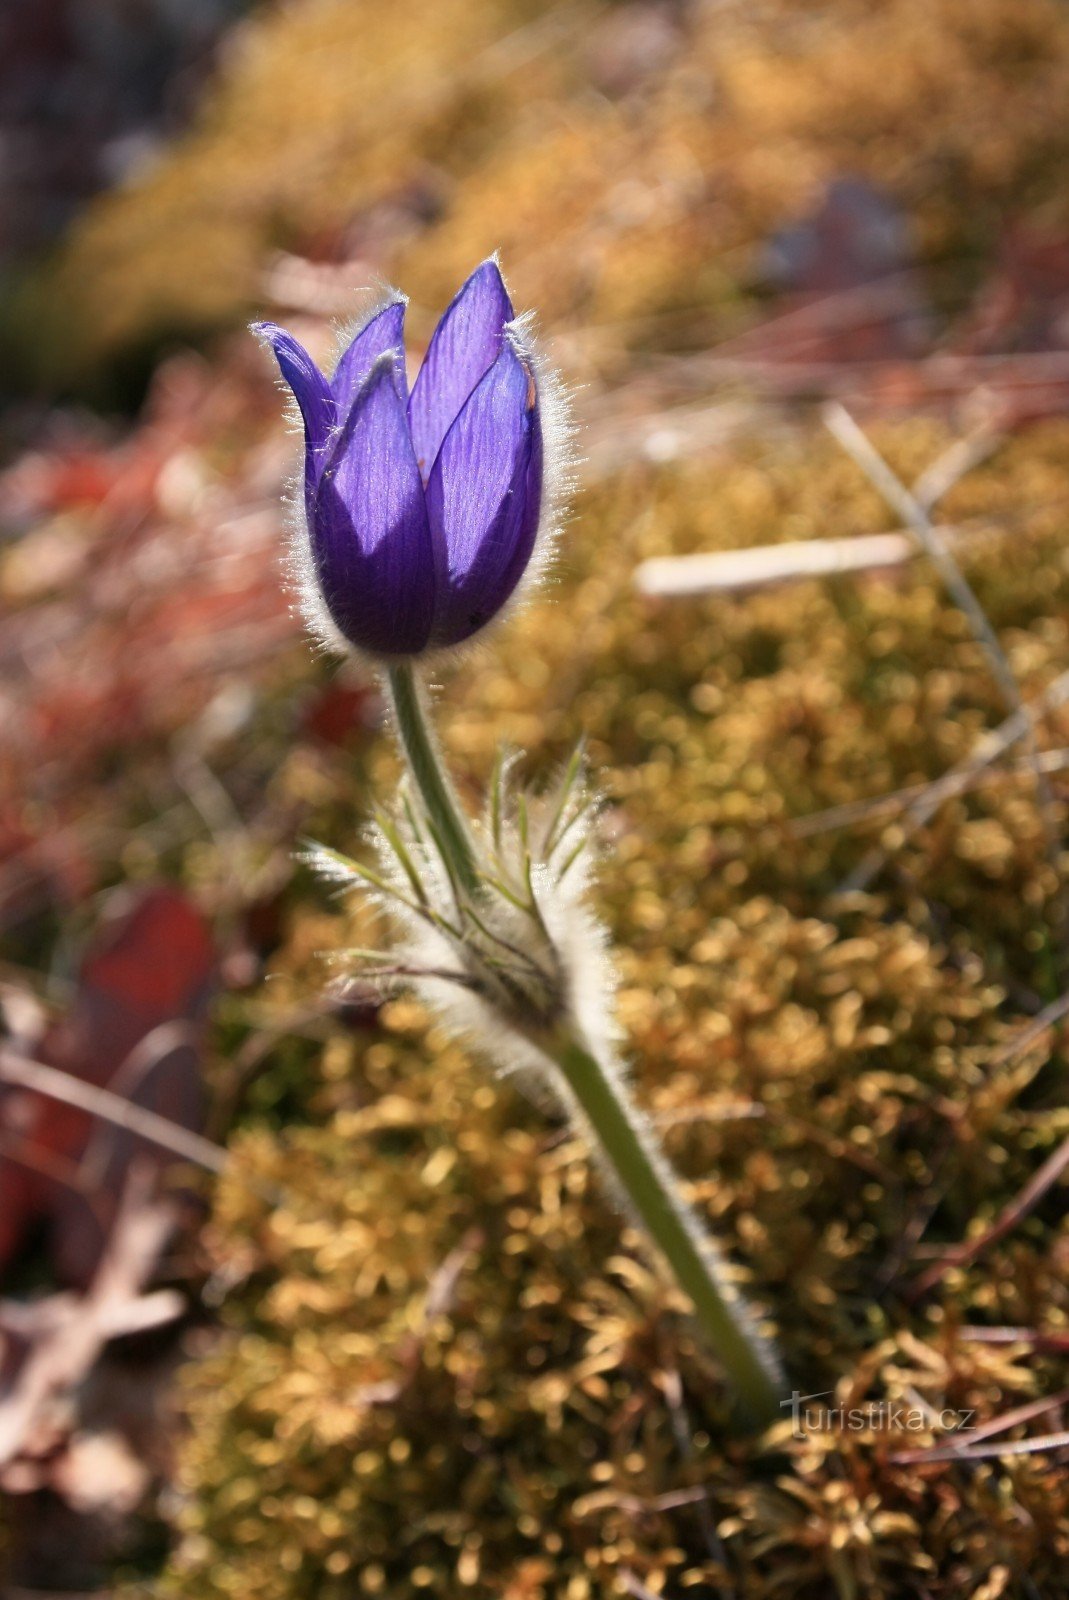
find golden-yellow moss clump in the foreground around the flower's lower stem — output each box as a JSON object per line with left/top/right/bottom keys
{"left": 166, "top": 424, "right": 1069, "bottom": 1600}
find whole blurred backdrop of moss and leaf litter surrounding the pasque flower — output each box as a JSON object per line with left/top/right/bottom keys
{"left": 0, "top": 0, "right": 1069, "bottom": 1600}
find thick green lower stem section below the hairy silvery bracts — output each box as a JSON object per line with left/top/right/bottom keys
{"left": 552, "top": 1037, "right": 783, "bottom": 1427}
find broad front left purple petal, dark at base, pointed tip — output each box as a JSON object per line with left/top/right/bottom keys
{"left": 310, "top": 350, "right": 435, "bottom": 656}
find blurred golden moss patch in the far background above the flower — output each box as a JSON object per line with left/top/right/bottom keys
{"left": 27, "top": 0, "right": 1069, "bottom": 382}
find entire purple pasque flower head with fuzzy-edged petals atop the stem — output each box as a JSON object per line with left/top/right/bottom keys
{"left": 253, "top": 261, "right": 546, "bottom": 659}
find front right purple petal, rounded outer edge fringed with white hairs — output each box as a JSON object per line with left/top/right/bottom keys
{"left": 427, "top": 342, "right": 543, "bottom": 645}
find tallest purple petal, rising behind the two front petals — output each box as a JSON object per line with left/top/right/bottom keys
{"left": 408, "top": 261, "right": 514, "bottom": 478}
